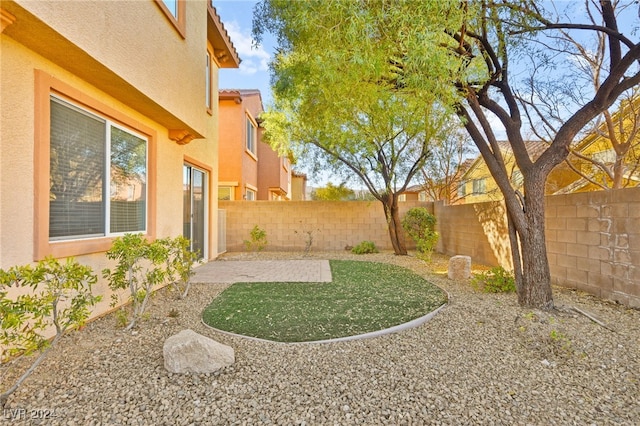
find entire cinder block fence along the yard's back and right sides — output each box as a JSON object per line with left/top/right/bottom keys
{"left": 219, "top": 188, "right": 640, "bottom": 307}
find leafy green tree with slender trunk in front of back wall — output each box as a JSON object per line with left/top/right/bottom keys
{"left": 254, "top": 0, "right": 467, "bottom": 254}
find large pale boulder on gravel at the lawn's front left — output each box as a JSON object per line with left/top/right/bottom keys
{"left": 163, "top": 330, "right": 235, "bottom": 373}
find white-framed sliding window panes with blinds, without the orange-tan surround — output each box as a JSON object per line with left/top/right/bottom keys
{"left": 49, "top": 96, "right": 148, "bottom": 241}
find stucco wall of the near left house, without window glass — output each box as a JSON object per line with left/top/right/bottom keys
{"left": 0, "top": 0, "right": 238, "bottom": 313}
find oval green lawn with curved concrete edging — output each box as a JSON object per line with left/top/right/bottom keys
{"left": 202, "top": 260, "right": 446, "bottom": 342}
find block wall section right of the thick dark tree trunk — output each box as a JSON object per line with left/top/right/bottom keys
{"left": 546, "top": 188, "right": 640, "bottom": 308}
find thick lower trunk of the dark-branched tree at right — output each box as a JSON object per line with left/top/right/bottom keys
{"left": 514, "top": 184, "right": 553, "bottom": 310}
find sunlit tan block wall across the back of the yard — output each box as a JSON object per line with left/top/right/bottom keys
{"left": 218, "top": 201, "right": 433, "bottom": 251}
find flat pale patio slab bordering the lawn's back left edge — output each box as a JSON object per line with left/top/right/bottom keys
{"left": 192, "top": 260, "right": 332, "bottom": 283}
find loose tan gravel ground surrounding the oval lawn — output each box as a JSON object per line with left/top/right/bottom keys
{"left": 0, "top": 252, "right": 640, "bottom": 425}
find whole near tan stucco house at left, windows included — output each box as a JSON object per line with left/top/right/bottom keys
{"left": 0, "top": 0, "right": 239, "bottom": 312}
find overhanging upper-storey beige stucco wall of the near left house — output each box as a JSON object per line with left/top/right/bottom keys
{"left": 3, "top": 0, "right": 207, "bottom": 135}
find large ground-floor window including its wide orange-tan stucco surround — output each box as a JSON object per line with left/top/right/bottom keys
{"left": 33, "top": 70, "right": 157, "bottom": 261}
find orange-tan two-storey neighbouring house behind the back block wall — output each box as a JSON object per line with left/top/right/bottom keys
{"left": 218, "top": 90, "right": 291, "bottom": 201}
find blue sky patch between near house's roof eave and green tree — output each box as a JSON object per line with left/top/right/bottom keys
{"left": 213, "top": 0, "right": 274, "bottom": 108}
